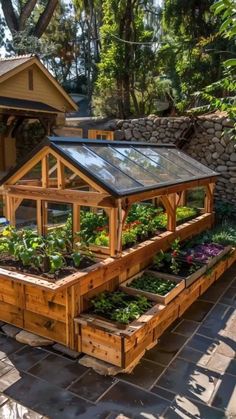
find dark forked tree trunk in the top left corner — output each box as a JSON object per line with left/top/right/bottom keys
{"left": 1, "top": 0, "right": 58, "bottom": 39}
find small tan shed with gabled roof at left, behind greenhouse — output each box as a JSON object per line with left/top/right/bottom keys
{"left": 0, "top": 55, "right": 77, "bottom": 174}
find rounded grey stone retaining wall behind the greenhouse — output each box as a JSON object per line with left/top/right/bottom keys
{"left": 115, "top": 114, "right": 236, "bottom": 205}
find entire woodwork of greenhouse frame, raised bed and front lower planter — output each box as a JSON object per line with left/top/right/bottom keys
{"left": 0, "top": 139, "right": 221, "bottom": 368}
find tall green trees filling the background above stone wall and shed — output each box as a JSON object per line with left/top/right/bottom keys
{"left": 0, "top": 0, "right": 236, "bottom": 118}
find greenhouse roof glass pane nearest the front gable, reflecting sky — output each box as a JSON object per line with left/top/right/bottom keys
{"left": 57, "top": 144, "right": 142, "bottom": 191}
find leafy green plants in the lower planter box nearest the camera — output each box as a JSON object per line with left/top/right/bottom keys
{"left": 90, "top": 291, "right": 152, "bottom": 324}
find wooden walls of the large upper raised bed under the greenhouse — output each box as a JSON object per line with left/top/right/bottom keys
{"left": 0, "top": 217, "right": 218, "bottom": 352}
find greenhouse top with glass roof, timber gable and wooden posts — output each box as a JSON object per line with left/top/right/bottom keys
{"left": 1, "top": 137, "right": 217, "bottom": 257}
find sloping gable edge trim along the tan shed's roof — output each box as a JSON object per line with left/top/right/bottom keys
{"left": 0, "top": 57, "right": 78, "bottom": 111}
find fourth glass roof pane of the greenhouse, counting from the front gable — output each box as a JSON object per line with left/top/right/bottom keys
{"left": 132, "top": 147, "right": 192, "bottom": 181}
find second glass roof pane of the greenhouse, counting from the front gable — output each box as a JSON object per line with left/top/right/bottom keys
{"left": 91, "top": 146, "right": 160, "bottom": 186}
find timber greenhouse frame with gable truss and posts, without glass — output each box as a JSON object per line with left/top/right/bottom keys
{"left": 4, "top": 146, "right": 215, "bottom": 258}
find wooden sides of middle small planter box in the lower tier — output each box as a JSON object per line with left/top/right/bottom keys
{"left": 120, "top": 270, "right": 185, "bottom": 305}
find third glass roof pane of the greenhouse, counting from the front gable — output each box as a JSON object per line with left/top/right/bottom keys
{"left": 115, "top": 147, "right": 177, "bottom": 183}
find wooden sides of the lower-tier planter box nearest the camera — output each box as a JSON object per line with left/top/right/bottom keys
{"left": 75, "top": 304, "right": 178, "bottom": 369}
